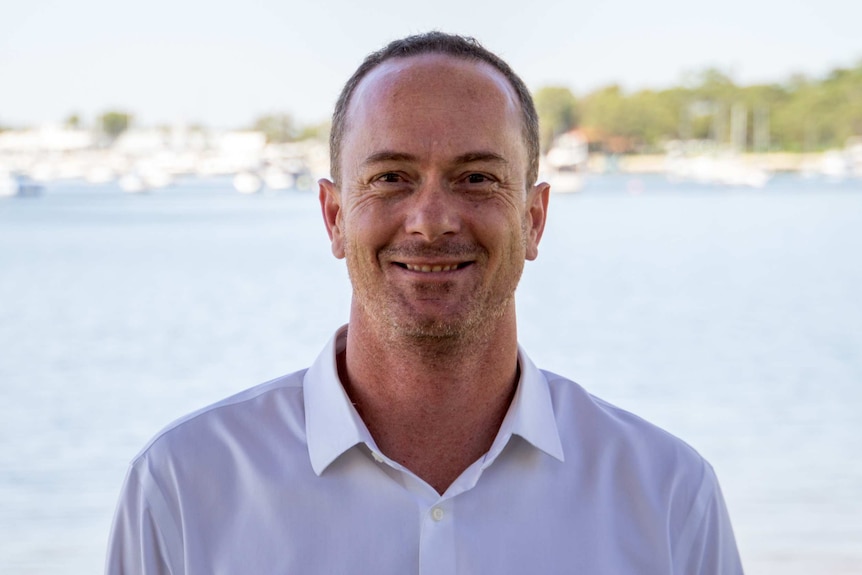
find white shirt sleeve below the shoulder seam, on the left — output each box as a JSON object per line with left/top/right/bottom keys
{"left": 105, "top": 466, "right": 184, "bottom": 575}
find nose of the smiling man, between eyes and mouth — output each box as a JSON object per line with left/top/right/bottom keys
{"left": 406, "top": 181, "right": 461, "bottom": 242}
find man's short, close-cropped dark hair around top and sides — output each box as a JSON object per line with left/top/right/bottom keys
{"left": 329, "top": 31, "right": 539, "bottom": 185}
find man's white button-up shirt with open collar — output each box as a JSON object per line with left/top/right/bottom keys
{"left": 107, "top": 328, "right": 742, "bottom": 575}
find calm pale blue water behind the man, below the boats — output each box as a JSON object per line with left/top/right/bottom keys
{"left": 0, "top": 176, "right": 862, "bottom": 575}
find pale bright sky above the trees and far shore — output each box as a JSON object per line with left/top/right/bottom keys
{"left": 0, "top": 0, "right": 862, "bottom": 128}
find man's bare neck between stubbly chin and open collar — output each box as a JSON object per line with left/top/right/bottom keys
{"left": 338, "top": 311, "right": 518, "bottom": 493}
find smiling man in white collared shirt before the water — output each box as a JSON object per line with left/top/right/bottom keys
{"left": 108, "top": 33, "right": 742, "bottom": 575}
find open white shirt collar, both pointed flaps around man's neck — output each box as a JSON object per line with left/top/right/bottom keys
{"left": 303, "top": 325, "right": 563, "bottom": 475}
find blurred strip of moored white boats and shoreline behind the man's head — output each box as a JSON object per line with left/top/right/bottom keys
{"left": 5, "top": 125, "right": 862, "bottom": 197}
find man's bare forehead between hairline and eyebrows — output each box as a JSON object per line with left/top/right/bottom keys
{"left": 343, "top": 54, "right": 523, "bottom": 164}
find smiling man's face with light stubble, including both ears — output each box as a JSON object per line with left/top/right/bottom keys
{"left": 321, "top": 54, "right": 548, "bottom": 338}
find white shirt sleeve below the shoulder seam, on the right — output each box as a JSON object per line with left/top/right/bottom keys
{"left": 674, "top": 462, "right": 743, "bottom": 575}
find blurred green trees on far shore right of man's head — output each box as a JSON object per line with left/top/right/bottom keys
{"left": 534, "top": 61, "right": 862, "bottom": 153}
